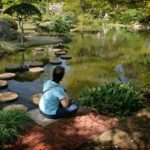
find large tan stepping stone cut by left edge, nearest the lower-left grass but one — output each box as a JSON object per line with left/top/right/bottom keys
{"left": 0, "top": 92, "right": 18, "bottom": 102}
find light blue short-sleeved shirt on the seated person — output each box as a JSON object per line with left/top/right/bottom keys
{"left": 39, "top": 80, "right": 65, "bottom": 115}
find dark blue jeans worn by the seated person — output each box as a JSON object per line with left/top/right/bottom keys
{"left": 40, "top": 102, "right": 79, "bottom": 119}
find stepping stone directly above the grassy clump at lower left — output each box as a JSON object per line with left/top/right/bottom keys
{"left": 3, "top": 104, "right": 28, "bottom": 112}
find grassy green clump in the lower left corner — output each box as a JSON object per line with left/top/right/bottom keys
{"left": 0, "top": 110, "right": 29, "bottom": 147}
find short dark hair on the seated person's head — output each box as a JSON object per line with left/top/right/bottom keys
{"left": 52, "top": 66, "right": 65, "bottom": 83}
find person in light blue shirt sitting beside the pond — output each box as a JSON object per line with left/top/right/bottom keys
{"left": 39, "top": 66, "right": 79, "bottom": 119}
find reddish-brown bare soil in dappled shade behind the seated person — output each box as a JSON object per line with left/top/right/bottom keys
{"left": 4, "top": 109, "right": 116, "bottom": 150}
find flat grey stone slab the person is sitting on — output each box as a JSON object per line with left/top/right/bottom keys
{"left": 27, "top": 109, "right": 60, "bottom": 127}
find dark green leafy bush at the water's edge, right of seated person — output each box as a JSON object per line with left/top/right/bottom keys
{"left": 78, "top": 83, "right": 142, "bottom": 116}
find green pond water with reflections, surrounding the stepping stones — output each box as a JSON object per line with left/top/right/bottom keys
{"left": 0, "top": 29, "right": 150, "bottom": 108}
